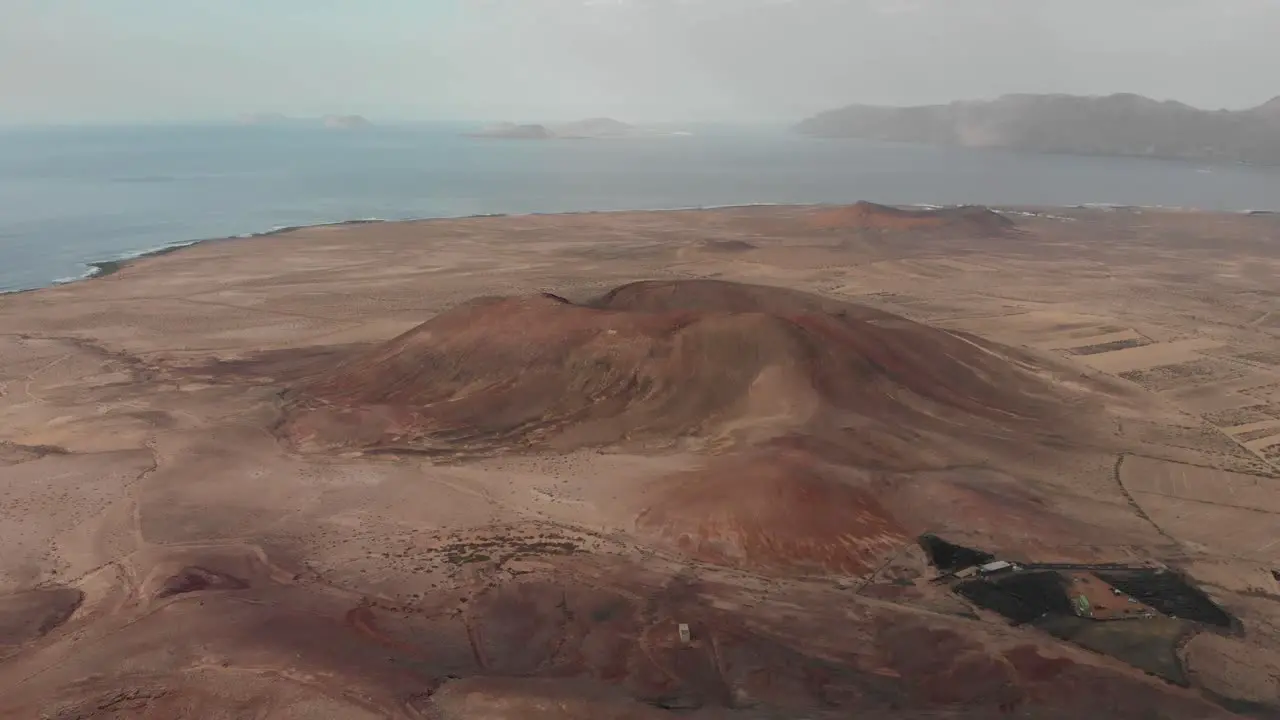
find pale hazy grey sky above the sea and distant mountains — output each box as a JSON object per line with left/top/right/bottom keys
{"left": 0, "top": 0, "right": 1280, "bottom": 122}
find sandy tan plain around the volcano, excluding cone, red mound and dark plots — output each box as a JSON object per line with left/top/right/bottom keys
{"left": 0, "top": 208, "right": 1280, "bottom": 719}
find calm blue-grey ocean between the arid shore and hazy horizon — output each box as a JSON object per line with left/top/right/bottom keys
{"left": 0, "top": 124, "right": 1280, "bottom": 292}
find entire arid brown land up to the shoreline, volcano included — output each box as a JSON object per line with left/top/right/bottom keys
{"left": 0, "top": 205, "right": 1280, "bottom": 720}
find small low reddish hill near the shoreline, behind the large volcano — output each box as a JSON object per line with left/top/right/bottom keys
{"left": 810, "top": 202, "right": 1016, "bottom": 237}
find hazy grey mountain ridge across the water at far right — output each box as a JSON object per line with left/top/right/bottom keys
{"left": 795, "top": 94, "right": 1280, "bottom": 165}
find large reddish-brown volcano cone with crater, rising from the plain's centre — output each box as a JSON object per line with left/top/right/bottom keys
{"left": 282, "top": 281, "right": 1057, "bottom": 456}
